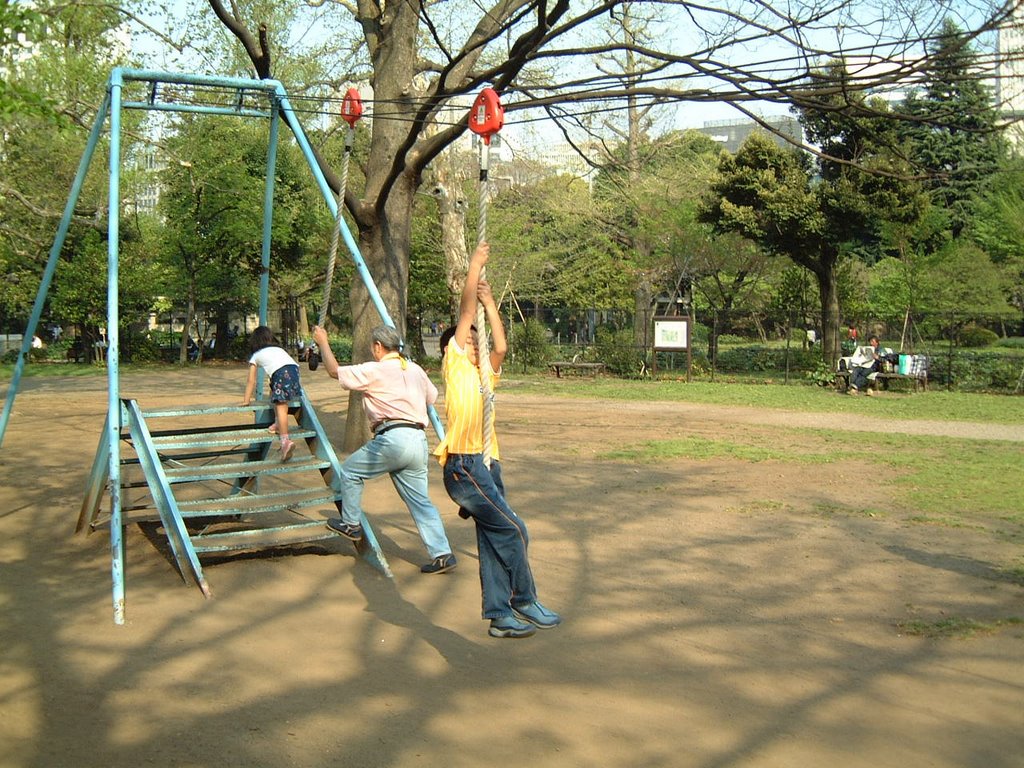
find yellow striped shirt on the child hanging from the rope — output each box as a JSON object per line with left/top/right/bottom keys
{"left": 434, "top": 339, "right": 501, "bottom": 466}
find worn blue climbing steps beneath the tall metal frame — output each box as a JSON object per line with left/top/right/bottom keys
{"left": 76, "top": 393, "right": 391, "bottom": 597}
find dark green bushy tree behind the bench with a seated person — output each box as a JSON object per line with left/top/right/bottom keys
{"left": 701, "top": 94, "right": 925, "bottom": 361}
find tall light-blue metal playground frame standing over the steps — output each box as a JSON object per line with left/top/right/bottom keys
{"left": 0, "top": 68, "right": 443, "bottom": 624}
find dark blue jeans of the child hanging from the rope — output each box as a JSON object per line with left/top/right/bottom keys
{"left": 444, "top": 454, "right": 537, "bottom": 618}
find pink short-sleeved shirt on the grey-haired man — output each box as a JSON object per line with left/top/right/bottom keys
{"left": 338, "top": 352, "right": 437, "bottom": 426}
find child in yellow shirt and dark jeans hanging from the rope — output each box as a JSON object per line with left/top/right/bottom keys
{"left": 434, "top": 243, "right": 562, "bottom": 638}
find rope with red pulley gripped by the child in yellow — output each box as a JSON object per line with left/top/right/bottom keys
{"left": 469, "top": 88, "right": 505, "bottom": 467}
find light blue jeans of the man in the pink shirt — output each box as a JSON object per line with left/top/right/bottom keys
{"left": 341, "top": 428, "right": 452, "bottom": 558}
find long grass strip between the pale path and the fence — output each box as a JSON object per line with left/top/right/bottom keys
{"left": 502, "top": 375, "right": 1024, "bottom": 424}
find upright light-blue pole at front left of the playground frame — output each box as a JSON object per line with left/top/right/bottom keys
{"left": 106, "top": 69, "right": 125, "bottom": 624}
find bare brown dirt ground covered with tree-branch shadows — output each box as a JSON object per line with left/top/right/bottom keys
{"left": 0, "top": 368, "right": 1024, "bottom": 768}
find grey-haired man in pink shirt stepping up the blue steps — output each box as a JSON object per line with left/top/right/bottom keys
{"left": 313, "top": 326, "right": 456, "bottom": 573}
